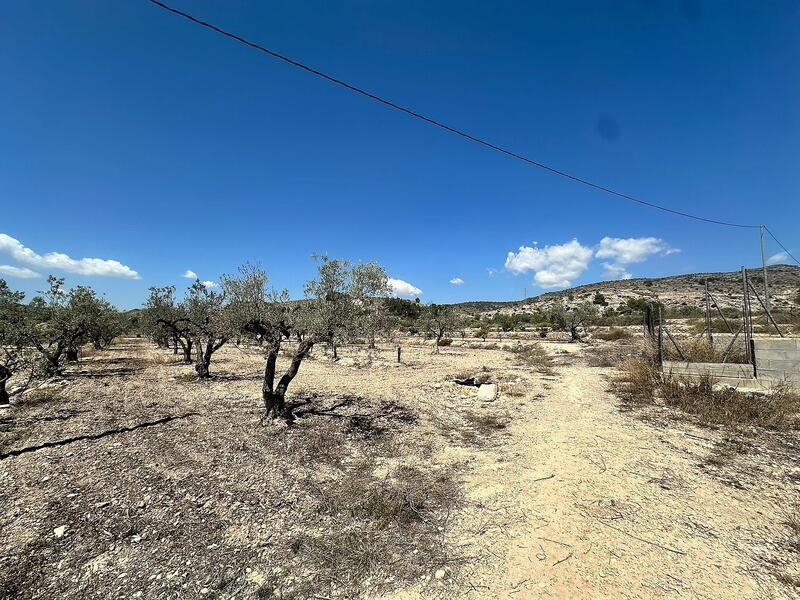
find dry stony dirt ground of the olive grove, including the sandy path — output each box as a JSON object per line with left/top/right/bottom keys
{"left": 0, "top": 339, "right": 800, "bottom": 598}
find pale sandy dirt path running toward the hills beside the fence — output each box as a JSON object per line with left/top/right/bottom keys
{"left": 450, "top": 366, "right": 789, "bottom": 598}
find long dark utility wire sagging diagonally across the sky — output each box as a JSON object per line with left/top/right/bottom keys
{"left": 148, "top": 0, "right": 774, "bottom": 229}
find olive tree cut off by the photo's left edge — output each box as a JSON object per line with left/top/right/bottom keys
{"left": 0, "top": 279, "right": 37, "bottom": 406}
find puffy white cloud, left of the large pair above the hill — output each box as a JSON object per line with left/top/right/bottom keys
{"left": 506, "top": 240, "right": 593, "bottom": 288}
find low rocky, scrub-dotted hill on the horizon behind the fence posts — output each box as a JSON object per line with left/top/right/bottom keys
{"left": 457, "top": 265, "right": 800, "bottom": 313}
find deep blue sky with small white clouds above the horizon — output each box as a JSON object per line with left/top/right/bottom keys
{"left": 0, "top": 0, "right": 800, "bottom": 307}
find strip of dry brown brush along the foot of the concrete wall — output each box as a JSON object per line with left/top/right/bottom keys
{"left": 616, "top": 358, "right": 800, "bottom": 430}
